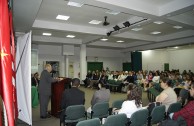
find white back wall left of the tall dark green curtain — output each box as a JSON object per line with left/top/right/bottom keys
{"left": 32, "top": 45, "right": 131, "bottom": 77}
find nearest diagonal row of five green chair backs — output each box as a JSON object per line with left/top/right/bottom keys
{"left": 76, "top": 102, "right": 181, "bottom": 126}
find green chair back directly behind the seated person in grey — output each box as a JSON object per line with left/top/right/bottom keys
{"left": 87, "top": 102, "right": 109, "bottom": 119}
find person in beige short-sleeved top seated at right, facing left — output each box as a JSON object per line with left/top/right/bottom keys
{"left": 156, "top": 77, "right": 177, "bottom": 111}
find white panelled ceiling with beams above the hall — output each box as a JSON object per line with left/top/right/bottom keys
{"left": 13, "top": 0, "right": 194, "bottom": 52}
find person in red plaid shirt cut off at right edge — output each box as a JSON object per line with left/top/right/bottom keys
{"left": 170, "top": 83, "right": 194, "bottom": 126}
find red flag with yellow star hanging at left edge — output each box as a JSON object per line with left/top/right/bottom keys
{"left": 0, "top": 0, "right": 14, "bottom": 126}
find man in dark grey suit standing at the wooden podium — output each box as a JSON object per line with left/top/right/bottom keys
{"left": 39, "top": 64, "right": 57, "bottom": 119}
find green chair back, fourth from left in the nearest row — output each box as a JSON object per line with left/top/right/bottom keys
{"left": 151, "top": 105, "right": 165, "bottom": 124}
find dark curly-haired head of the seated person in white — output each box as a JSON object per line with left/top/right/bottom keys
{"left": 127, "top": 88, "right": 141, "bottom": 107}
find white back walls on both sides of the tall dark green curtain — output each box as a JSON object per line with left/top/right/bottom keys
{"left": 32, "top": 45, "right": 194, "bottom": 77}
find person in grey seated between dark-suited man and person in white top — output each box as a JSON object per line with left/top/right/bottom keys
{"left": 87, "top": 83, "right": 110, "bottom": 112}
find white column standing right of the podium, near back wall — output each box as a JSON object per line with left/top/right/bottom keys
{"left": 80, "top": 44, "right": 87, "bottom": 80}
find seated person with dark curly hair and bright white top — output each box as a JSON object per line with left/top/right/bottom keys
{"left": 118, "top": 84, "right": 142, "bottom": 118}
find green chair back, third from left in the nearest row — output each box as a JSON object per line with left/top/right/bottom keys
{"left": 130, "top": 109, "right": 148, "bottom": 126}
